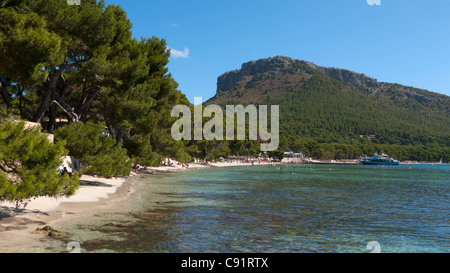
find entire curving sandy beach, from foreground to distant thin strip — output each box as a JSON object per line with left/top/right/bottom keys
{"left": 0, "top": 161, "right": 269, "bottom": 253}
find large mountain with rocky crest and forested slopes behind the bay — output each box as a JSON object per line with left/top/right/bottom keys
{"left": 206, "top": 56, "right": 450, "bottom": 151}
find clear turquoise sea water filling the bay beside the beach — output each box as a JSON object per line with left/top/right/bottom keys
{"left": 53, "top": 164, "right": 450, "bottom": 253}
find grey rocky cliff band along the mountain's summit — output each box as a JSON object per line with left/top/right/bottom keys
{"left": 216, "top": 56, "right": 381, "bottom": 97}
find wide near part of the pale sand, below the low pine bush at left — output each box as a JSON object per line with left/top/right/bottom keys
{"left": 0, "top": 174, "right": 134, "bottom": 253}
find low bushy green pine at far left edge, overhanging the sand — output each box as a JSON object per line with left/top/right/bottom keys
{"left": 0, "top": 119, "right": 78, "bottom": 207}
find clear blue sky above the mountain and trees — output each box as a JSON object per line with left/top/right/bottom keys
{"left": 106, "top": 0, "right": 450, "bottom": 101}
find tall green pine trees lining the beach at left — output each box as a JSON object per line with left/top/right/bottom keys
{"left": 0, "top": 0, "right": 190, "bottom": 203}
